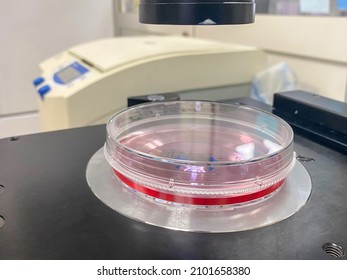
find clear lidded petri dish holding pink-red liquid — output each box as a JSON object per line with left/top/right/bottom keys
{"left": 104, "top": 101, "right": 295, "bottom": 209}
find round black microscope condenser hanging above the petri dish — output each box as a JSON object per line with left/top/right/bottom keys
{"left": 139, "top": 0, "right": 255, "bottom": 25}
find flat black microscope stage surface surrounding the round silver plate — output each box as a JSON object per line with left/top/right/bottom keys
{"left": 0, "top": 115, "right": 347, "bottom": 260}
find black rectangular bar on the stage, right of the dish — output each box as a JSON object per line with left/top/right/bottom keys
{"left": 273, "top": 90, "right": 347, "bottom": 153}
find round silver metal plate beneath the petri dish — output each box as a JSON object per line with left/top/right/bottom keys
{"left": 86, "top": 148, "right": 312, "bottom": 232}
